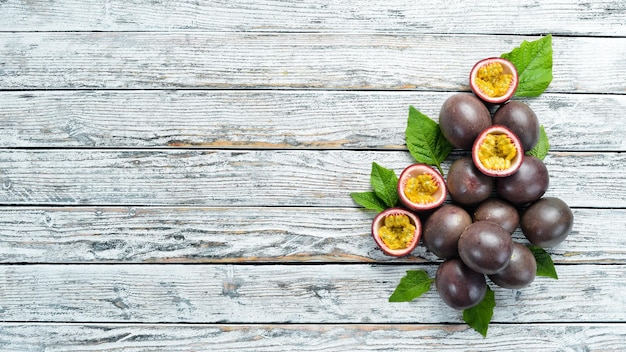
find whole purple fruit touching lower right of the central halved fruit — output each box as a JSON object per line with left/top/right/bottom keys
{"left": 496, "top": 155, "right": 550, "bottom": 205}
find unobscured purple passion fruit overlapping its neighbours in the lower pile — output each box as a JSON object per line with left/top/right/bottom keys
{"left": 458, "top": 221, "right": 513, "bottom": 275}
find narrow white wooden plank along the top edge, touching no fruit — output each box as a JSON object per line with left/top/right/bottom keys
{"left": 0, "top": 0, "right": 626, "bottom": 36}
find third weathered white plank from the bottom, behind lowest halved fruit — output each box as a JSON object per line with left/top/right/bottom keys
{"left": 0, "top": 207, "right": 626, "bottom": 264}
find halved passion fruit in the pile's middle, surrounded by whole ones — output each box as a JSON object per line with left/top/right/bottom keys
{"left": 472, "top": 125, "right": 524, "bottom": 177}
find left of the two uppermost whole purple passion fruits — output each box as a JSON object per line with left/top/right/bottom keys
{"left": 439, "top": 93, "right": 491, "bottom": 150}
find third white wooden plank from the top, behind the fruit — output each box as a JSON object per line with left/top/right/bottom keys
{"left": 0, "top": 90, "right": 626, "bottom": 151}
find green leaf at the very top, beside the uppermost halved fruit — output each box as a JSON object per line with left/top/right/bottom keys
{"left": 501, "top": 35, "right": 552, "bottom": 97}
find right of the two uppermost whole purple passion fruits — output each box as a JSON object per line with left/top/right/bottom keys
{"left": 493, "top": 100, "right": 540, "bottom": 152}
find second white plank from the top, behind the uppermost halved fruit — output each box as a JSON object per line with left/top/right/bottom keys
{"left": 0, "top": 32, "right": 626, "bottom": 94}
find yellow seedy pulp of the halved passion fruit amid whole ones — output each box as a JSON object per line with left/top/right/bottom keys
{"left": 478, "top": 132, "right": 517, "bottom": 170}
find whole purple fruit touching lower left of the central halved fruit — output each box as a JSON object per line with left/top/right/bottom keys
{"left": 447, "top": 157, "right": 493, "bottom": 205}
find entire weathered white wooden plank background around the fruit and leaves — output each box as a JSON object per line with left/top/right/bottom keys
{"left": 0, "top": 0, "right": 626, "bottom": 352}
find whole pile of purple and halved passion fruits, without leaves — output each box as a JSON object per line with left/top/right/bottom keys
{"left": 372, "top": 58, "right": 573, "bottom": 309}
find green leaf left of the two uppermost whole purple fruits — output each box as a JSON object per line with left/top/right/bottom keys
{"left": 405, "top": 106, "right": 452, "bottom": 175}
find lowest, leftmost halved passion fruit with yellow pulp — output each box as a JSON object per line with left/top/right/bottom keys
{"left": 372, "top": 208, "right": 422, "bottom": 257}
